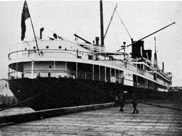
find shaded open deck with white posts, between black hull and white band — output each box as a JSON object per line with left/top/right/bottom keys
{"left": 10, "top": 61, "right": 124, "bottom": 84}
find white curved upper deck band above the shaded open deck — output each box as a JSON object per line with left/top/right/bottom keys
{"left": 8, "top": 40, "right": 153, "bottom": 79}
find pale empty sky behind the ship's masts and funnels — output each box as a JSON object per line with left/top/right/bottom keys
{"left": 0, "top": 0, "right": 182, "bottom": 86}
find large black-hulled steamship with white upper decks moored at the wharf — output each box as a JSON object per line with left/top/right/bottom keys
{"left": 8, "top": 1, "right": 174, "bottom": 110}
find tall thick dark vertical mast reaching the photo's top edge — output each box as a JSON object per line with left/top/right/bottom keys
{"left": 100, "top": 0, "right": 104, "bottom": 47}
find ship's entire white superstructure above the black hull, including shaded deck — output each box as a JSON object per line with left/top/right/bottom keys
{"left": 8, "top": 40, "right": 171, "bottom": 90}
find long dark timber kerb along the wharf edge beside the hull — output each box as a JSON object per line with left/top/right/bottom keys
{"left": 0, "top": 102, "right": 114, "bottom": 127}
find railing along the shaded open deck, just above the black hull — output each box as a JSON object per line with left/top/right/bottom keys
{"left": 8, "top": 70, "right": 123, "bottom": 84}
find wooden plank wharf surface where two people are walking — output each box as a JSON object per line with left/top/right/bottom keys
{"left": 0, "top": 103, "right": 182, "bottom": 136}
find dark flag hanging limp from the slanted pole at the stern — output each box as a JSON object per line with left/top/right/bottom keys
{"left": 21, "top": 0, "right": 30, "bottom": 41}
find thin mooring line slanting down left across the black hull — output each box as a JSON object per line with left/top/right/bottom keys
{"left": 0, "top": 78, "right": 60, "bottom": 112}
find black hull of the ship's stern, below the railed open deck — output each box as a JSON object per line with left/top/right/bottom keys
{"left": 9, "top": 78, "right": 124, "bottom": 110}
